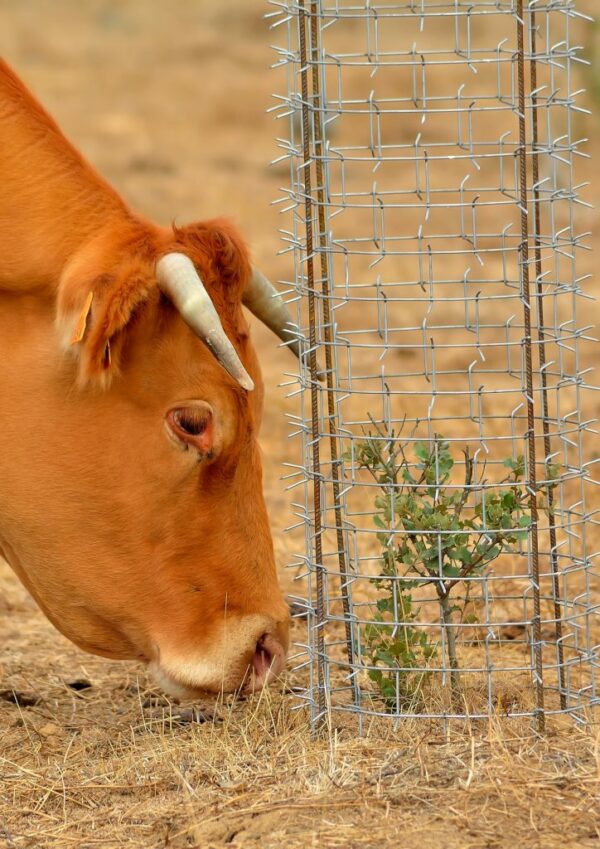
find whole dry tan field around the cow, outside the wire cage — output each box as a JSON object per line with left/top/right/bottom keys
{"left": 0, "top": 0, "right": 600, "bottom": 849}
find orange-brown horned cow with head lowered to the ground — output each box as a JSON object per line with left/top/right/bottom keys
{"left": 0, "top": 61, "right": 298, "bottom": 695}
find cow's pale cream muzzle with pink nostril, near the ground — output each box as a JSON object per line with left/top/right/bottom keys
{"left": 150, "top": 615, "right": 289, "bottom": 698}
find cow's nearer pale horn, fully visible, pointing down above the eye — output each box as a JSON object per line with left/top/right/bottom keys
{"left": 156, "top": 253, "right": 254, "bottom": 392}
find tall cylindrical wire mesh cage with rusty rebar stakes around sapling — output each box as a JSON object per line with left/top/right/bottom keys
{"left": 271, "top": 0, "right": 598, "bottom": 729}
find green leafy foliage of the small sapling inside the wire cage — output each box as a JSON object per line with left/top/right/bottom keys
{"left": 352, "top": 428, "right": 548, "bottom": 712}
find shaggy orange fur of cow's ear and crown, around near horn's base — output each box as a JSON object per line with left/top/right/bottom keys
{"left": 57, "top": 220, "right": 250, "bottom": 388}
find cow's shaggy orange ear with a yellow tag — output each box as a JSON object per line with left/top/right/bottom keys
{"left": 57, "top": 258, "right": 156, "bottom": 388}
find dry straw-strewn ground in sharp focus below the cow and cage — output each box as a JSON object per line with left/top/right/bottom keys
{"left": 0, "top": 623, "right": 600, "bottom": 849}
